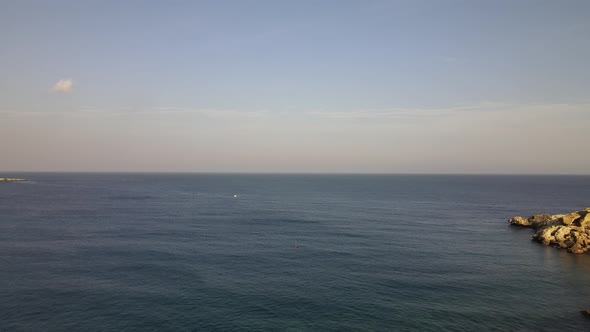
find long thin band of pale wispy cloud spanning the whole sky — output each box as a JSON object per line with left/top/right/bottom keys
{"left": 0, "top": 100, "right": 590, "bottom": 125}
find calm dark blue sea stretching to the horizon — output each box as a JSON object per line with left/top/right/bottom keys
{"left": 0, "top": 173, "right": 590, "bottom": 331}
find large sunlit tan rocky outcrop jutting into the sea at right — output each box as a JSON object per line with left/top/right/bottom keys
{"left": 508, "top": 208, "right": 590, "bottom": 254}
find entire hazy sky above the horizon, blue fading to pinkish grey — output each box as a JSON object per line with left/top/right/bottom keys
{"left": 0, "top": 0, "right": 590, "bottom": 174}
